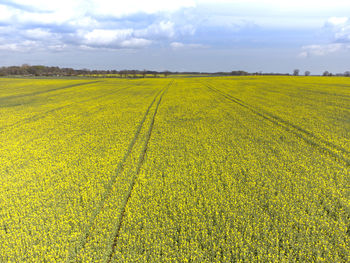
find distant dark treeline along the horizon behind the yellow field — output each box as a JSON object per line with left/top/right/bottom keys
{"left": 0, "top": 64, "right": 350, "bottom": 78}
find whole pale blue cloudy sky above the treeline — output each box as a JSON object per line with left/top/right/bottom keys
{"left": 0, "top": 0, "right": 350, "bottom": 74}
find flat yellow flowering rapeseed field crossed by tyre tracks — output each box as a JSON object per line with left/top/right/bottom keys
{"left": 0, "top": 76, "right": 350, "bottom": 262}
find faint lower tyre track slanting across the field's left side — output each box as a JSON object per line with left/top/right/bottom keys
{"left": 0, "top": 82, "right": 144, "bottom": 133}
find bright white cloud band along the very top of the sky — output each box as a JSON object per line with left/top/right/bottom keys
{"left": 6, "top": 0, "right": 350, "bottom": 17}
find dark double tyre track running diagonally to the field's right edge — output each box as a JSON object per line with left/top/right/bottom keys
{"left": 203, "top": 83, "right": 350, "bottom": 166}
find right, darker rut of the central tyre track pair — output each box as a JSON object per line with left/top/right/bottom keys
{"left": 104, "top": 81, "right": 174, "bottom": 263}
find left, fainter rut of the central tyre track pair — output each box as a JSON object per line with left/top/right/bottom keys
{"left": 66, "top": 82, "right": 170, "bottom": 262}
